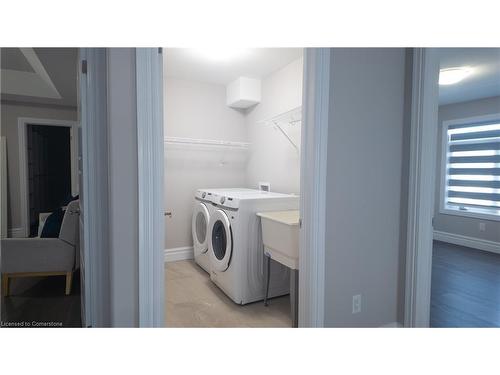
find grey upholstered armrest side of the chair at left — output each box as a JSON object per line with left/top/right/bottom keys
{"left": 0, "top": 238, "right": 75, "bottom": 273}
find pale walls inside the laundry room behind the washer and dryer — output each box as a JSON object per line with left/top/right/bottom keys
{"left": 164, "top": 59, "right": 303, "bottom": 253}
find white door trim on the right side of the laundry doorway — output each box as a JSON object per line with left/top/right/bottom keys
{"left": 299, "top": 48, "right": 331, "bottom": 327}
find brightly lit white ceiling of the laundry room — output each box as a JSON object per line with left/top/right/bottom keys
{"left": 164, "top": 48, "right": 302, "bottom": 85}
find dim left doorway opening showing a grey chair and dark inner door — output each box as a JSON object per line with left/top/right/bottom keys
{"left": 1, "top": 48, "right": 82, "bottom": 327}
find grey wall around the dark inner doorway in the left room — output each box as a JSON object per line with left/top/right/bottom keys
{"left": 1, "top": 102, "right": 77, "bottom": 234}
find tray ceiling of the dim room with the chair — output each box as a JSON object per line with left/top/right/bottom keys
{"left": 0, "top": 48, "right": 78, "bottom": 107}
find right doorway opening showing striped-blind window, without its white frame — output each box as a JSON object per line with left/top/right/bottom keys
{"left": 430, "top": 48, "right": 500, "bottom": 327}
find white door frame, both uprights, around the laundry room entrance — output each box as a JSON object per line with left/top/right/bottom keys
{"left": 142, "top": 48, "right": 331, "bottom": 327}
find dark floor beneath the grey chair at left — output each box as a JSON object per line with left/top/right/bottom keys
{"left": 1, "top": 272, "right": 81, "bottom": 327}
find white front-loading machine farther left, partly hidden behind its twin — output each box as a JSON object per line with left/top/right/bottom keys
{"left": 191, "top": 188, "right": 254, "bottom": 273}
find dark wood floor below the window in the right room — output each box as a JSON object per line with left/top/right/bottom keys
{"left": 430, "top": 241, "right": 500, "bottom": 327}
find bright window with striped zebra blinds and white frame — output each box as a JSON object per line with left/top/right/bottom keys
{"left": 441, "top": 114, "right": 500, "bottom": 220}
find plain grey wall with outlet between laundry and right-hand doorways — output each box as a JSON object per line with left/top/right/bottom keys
{"left": 325, "top": 48, "right": 405, "bottom": 327}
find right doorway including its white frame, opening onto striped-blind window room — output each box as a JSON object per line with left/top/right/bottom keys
{"left": 405, "top": 48, "right": 500, "bottom": 327}
